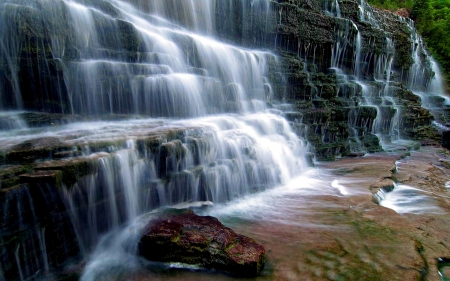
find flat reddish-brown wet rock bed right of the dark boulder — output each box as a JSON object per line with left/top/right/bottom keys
{"left": 179, "top": 147, "right": 450, "bottom": 280}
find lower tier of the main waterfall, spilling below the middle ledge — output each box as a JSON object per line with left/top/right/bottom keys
{"left": 60, "top": 113, "right": 307, "bottom": 254}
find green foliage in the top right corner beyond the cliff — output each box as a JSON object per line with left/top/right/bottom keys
{"left": 368, "top": 0, "right": 450, "bottom": 85}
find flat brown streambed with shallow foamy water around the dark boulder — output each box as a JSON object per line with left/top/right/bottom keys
{"left": 43, "top": 145, "right": 450, "bottom": 280}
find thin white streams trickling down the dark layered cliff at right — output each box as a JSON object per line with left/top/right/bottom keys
{"left": 331, "top": 1, "right": 436, "bottom": 151}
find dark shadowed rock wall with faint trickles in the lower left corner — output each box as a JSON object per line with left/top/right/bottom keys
{"left": 0, "top": 183, "right": 79, "bottom": 280}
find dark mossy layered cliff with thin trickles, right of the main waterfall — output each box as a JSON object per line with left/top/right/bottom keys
{"left": 266, "top": 0, "right": 439, "bottom": 160}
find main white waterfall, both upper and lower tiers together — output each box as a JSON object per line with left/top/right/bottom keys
{"left": 0, "top": 0, "right": 307, "bottom": 280}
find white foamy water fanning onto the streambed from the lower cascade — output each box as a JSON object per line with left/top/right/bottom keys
{"left": 201, "top": 169, "right": 359, "bottom": 227}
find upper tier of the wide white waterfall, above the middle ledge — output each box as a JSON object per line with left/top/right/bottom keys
{"left": 0, "top": 0, "right": 274, "bottom": 117}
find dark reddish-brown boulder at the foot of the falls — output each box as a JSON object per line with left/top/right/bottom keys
{"left": 139, "top": 210, "right": 266, "bottom": 276}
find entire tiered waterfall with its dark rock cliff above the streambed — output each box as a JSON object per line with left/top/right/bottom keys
{"left": 0, "top": 0, "right": 446, "bottom": 280}
